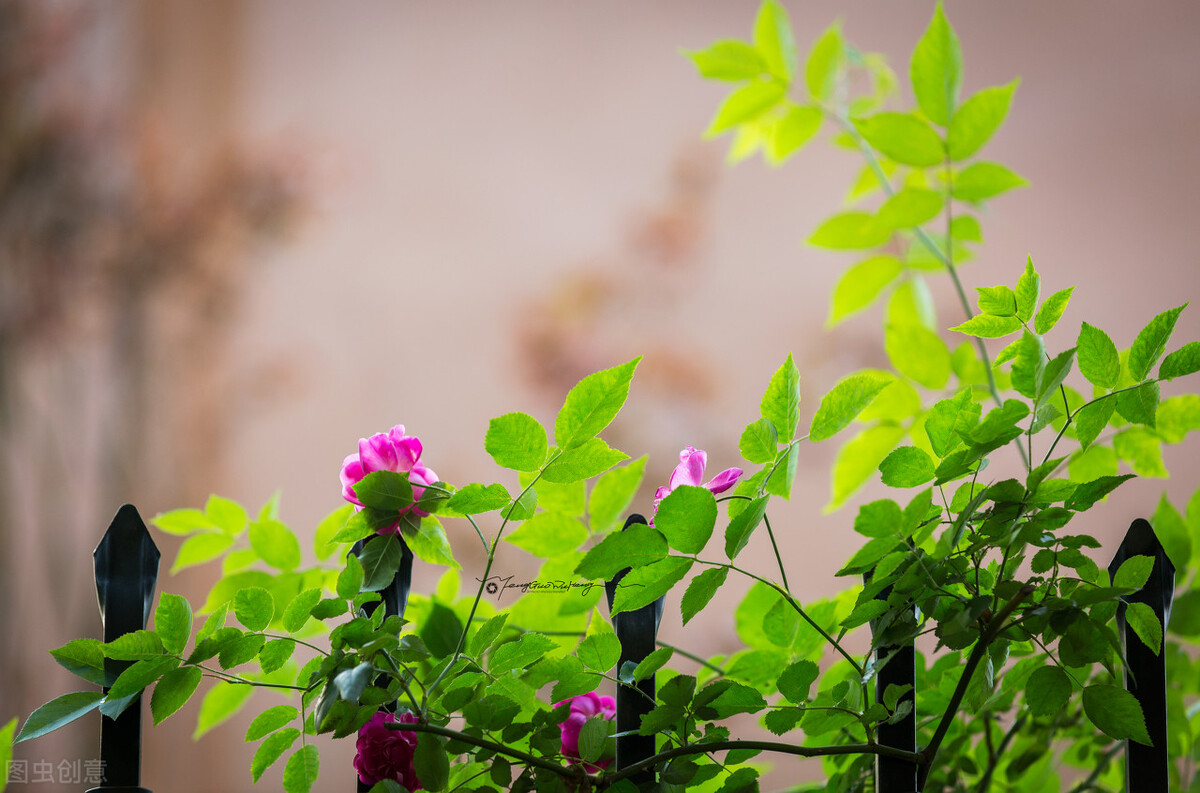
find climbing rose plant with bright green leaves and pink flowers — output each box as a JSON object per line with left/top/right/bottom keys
{"left": 7, "top": 0, "right": 1200, "bottom": 793}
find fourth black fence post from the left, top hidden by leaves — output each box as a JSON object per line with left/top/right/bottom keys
{"left": 864, "top": 573, "right": 918, "bottom": 793}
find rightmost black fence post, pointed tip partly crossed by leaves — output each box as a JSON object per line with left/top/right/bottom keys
{"left": 1109, "top": 518, "right": 1175, "bottom": 793}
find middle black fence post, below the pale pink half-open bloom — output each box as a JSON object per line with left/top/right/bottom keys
{"left": 605, "top": 515, "right": 665, "bottom": 789}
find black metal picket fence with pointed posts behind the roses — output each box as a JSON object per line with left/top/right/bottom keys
{"left": 89, "top": 504, "right": 1175, "bottom": 793}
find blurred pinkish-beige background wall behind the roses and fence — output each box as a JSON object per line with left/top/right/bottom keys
{"left": 7, "top": 0, "right": 1200, "bottom": 793}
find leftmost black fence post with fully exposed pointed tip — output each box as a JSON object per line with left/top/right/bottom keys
{"left": 89, "top": 504, "right": 161, "bottom": 793}
